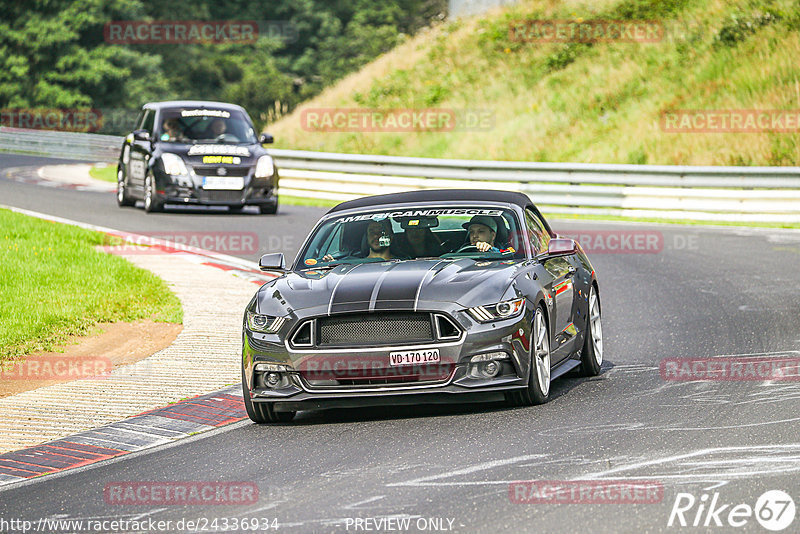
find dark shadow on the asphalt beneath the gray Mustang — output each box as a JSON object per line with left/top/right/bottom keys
{"left": 278, "top": 361, "right": 614, "bottom": 426}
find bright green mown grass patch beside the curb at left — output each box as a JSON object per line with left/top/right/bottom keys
{"left": 0, "top": 209, "right": 183, "bottom": 361}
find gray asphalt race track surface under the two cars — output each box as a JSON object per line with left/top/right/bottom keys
{"left": 0, "top": 155, "right": 800, "bottom": 533}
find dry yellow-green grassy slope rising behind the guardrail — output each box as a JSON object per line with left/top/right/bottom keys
{"left": 269, "top": 0, "right": 800, "bottom": 165}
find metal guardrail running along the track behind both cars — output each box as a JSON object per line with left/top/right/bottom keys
{"left": 0, "top": 128, "right": 800, "bottom": 222}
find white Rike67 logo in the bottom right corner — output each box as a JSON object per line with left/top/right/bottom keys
{"left": 667, "top": 490, "right": 795, "bottom": 532}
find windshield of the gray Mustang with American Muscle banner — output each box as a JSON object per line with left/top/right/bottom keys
{"left": 298, "top": 206, "right": 525, "bottom": 269}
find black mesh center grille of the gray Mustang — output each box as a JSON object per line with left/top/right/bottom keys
{"left": 317, "top": 313, "right": 434, "bottom": 347}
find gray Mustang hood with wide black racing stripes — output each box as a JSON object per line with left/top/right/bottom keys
{"left": 253, "top": 259, "right": 520, "bottom": 316}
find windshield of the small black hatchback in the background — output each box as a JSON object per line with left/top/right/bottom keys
{"left": 156, "top": 109, "right": 257, "bottom": 144}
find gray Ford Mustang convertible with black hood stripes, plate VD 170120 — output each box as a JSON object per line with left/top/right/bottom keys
{"left": 242, "top": 190, "right": 603, "bottom": 423}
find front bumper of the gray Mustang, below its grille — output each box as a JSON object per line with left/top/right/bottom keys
{"left": 242, "top": 312, "right": 532, "bottom": 411}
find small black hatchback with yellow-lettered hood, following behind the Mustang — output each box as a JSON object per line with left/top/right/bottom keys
{"left": 117, "top": 101, "right": 278, "bottom": 214}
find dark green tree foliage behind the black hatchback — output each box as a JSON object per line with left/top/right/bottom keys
{"left": 0, "top": 0, "right": 446, "bottom": 131}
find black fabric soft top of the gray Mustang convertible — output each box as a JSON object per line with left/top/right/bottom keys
{"left": 328, "top": 189, "right": 533, "bottom": 213}
